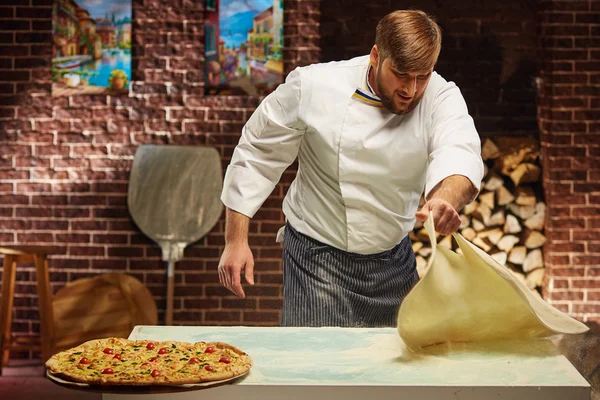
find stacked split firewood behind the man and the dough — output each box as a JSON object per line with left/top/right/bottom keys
{"left": 410, "top": 137, "right": 546, "bottom": 293}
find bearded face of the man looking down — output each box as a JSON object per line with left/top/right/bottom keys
{"left": 374, "top": 58, "right": 433, "bottom": 115}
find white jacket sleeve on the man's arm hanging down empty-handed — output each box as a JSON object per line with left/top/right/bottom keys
{"left": 221, "top": 69, "right": 306, "bottom": 218}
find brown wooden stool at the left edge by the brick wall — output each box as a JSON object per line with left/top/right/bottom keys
{"left": 0, "top": 246, "right": 58, "bottom": 374}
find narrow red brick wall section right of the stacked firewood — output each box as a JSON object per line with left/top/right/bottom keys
{"left": 538, "top": 0, "right": 600, "bottom": 322}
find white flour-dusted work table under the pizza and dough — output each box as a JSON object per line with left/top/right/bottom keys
{"left": 103, "top": 326, "right": 590, "bottom": 400}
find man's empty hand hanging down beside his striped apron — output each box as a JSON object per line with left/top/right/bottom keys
{"left": 219, "top": 242, "right": 254, "bottom": 299}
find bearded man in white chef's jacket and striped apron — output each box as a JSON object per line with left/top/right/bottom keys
{"left": 218, "top": 11, "right": 483, "bottom": 327}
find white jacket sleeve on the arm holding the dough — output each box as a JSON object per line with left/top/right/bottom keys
{"left": 425, "top": 83, "right": 483, "bottom": 198}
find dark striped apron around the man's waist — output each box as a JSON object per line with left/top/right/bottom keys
{"left": 281, "top": 223, "right": 419, "bottom": 327}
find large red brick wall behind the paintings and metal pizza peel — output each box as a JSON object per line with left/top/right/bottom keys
{"left": 0, "top": 0, "right": 319, "bottom": 350}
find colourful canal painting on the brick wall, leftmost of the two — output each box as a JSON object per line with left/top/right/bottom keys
{"left": 52, "top": 0, "right": 131, "bottom": 96}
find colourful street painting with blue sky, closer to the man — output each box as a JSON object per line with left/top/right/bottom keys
{"left": 205, "top": 0, "right": 283, "bottom": 96}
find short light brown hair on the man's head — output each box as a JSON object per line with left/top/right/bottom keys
{"left": 375, "top": 10, "right": 442, "bottom": 71}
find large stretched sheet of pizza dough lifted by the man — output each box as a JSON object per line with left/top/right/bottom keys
{"left": 398, "top": 215, "right": 589, "bottom": 350}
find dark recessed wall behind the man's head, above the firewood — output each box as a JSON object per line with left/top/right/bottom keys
{"left": 321, "top": 0, "right": 538, "bottom": 137}
